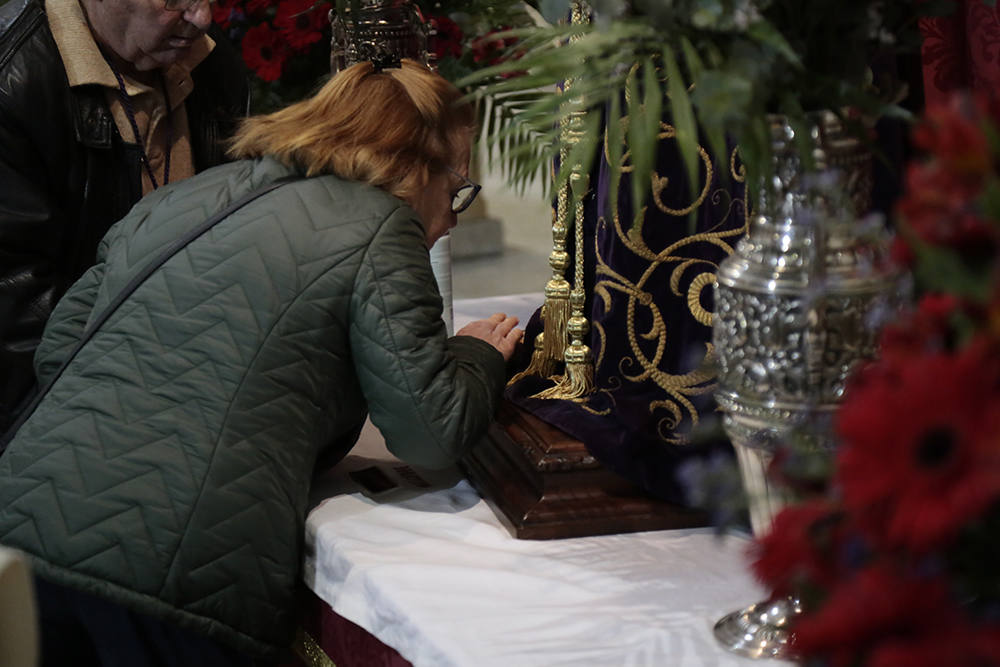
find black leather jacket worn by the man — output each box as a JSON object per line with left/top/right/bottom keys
{"left": 0, "top": 0, "right": 249, "bottom": 433}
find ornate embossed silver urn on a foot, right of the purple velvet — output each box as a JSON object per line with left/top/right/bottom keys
{"left": 712, "top": 112, "right": 900, "bottom": 657}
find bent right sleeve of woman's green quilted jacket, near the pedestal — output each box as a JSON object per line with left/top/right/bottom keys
{"left": 350, "top": 207, "right": 505, "bottom": 468}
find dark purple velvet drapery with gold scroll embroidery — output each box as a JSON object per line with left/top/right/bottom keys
{"left": 507, "top": 111, "right": 746, "bottom": 503}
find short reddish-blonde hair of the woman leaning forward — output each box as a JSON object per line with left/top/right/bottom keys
{"left": 229, "top": 59, "right": 476, "bottom": 200}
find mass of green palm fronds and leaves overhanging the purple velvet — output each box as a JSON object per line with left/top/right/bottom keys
{"left": 458, "top": 0, "right": 947, "bottom": 230}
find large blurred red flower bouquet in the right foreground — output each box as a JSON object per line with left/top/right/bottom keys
{"left": 753, "top": 91, "right": 1000, "bottom": 667}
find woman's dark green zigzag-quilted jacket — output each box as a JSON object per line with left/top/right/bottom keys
{"left": 0, "top": 158, "right": 504, "bottom": 656}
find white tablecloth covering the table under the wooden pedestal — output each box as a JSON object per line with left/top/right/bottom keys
{"left": 305, "top": 301, "right": 778, "bottom": 667}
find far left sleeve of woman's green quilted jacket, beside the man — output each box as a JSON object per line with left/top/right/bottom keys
{"left": 35, "top": 237, "right": 108, "bottom": 386}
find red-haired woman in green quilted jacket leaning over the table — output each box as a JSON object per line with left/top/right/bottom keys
{"left": 0, "top": 60, "right": 520, "bottom": 665}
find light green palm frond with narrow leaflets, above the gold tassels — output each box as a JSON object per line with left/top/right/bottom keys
{"left": 458, "top": 22, "right": 663, "bottom": 214}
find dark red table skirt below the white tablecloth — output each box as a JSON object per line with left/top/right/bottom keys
{"left": 282, "top": 592, "right": 412, "bottom": 667}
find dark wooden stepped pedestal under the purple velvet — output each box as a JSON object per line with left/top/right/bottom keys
{"left": 460, "top": 402, "right": 708, "bottom": 540}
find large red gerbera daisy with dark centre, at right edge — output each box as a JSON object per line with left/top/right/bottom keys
{"left": 836, "top": 341, "right": 1000, "bottom": 553}
